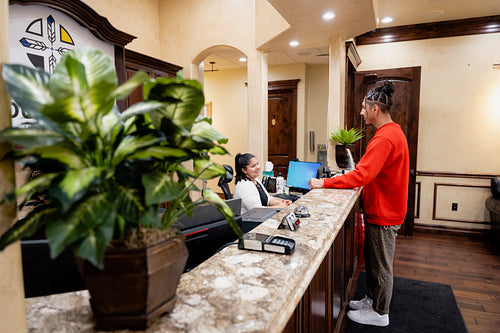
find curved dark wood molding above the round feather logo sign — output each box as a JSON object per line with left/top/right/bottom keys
{"left": 9, "top": 0, "right": 136, "bottom": 47}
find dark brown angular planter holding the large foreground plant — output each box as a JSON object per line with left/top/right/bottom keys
{"left": 77, "top": 233, "right": 188, "bottom": 330}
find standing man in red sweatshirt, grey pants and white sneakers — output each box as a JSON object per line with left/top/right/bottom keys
{"left": 309, "top": 81, "right": 410, "bottom": 326}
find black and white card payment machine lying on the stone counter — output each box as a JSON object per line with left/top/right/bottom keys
{"left": 238, "top": 232, "right": 295, "bottom": 254}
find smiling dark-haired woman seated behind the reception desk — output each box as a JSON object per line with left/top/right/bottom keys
{"left": 233, "top": 153, "right": 291, "bottom": 214}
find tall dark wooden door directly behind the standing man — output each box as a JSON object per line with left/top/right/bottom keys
{"left": 346, "top": 67, "right": 421, "bottom": 235}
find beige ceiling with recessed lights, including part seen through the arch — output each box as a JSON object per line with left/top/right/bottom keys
{"left": 204, "top": 0, "right": 500, "bottom": 70}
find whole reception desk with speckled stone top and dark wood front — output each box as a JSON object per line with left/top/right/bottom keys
{"left": 26, "top": 189, "right": 360, "bottom": 333}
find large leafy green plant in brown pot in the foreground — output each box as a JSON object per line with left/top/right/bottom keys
{"left": 0, "top": 49, "right": 241, "bottom": 329}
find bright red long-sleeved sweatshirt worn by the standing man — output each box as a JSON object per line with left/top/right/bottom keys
{"left": 325, "top": 122, "right": 410, "bottom": 225}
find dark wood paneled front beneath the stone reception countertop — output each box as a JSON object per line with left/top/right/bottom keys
{"left": 283, "top": 198, "right": 359, "bottom": 333}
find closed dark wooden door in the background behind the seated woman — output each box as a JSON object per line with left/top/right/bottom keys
{"left": 267, "top": 80, "right": 300, "bottom": 178}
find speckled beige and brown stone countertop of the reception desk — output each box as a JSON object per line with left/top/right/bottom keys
{"left": 26, "top": 189, "right": 360, "bottom": 333}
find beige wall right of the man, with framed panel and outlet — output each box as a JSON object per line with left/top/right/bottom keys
{"left": 357, "top": 34, "right": 500, "bottom": 228}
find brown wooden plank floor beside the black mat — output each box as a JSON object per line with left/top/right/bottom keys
{"left": 394, "top": 232, "right": 500, "bottom": 333}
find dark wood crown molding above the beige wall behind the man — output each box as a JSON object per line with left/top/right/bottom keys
{"left": 355, "top": 15, "right": 500, "bottom": 45}
